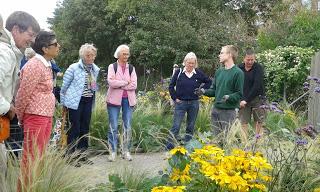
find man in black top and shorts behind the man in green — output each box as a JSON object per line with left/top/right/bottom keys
{"left": 239, "top": 49, "right": 265, "bottom": 139}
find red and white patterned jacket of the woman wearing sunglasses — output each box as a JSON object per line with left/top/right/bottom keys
{"left": 15, "top": 55, "right": 55, "bottom": 123}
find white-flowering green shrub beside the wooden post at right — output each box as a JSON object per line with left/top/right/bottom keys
{"left": 257, "top": 46, "right": 314, "bottom": 101}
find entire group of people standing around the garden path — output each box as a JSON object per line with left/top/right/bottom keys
{"left": 0, "top": 11, "right": 264, "bottom": 177}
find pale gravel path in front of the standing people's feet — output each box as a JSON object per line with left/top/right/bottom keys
{"left": 79, "top": 152, "right": 167, "bottom": 185}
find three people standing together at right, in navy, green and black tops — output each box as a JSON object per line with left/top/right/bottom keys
{"left": 166, "top": 45, "right": 265, "bottom": 150}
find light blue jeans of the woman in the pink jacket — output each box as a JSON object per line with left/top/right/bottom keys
{"left": 107, "top": 98, "right": 133, "bottom": 152}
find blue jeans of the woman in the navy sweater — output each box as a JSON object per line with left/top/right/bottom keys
{"left": 166, "top": 100, "right": 199, "bottom": 150}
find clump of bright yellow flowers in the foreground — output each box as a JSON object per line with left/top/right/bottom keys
{"left": 154, "top": 145, "right": 272, "bottom": 191}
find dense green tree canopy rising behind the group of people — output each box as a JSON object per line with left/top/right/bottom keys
{"left": 49, "top": 0, "right": 276, "bottom": 76}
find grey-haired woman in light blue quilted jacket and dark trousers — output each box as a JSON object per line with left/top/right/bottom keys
{"left": 60, "top": 43, "right": 100, "bottom": 164}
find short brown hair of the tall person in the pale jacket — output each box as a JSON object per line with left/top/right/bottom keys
{"left": 6, "top": 11, "right": 40, "bottom": 33}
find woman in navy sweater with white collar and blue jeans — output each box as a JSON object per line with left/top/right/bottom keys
{"left": 166, "top": 52, "right": 211, "bottom": 150}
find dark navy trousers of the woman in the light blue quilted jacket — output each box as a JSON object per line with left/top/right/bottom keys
{"left": 67, "top": 97, "right": 93, "bottom": 153}
